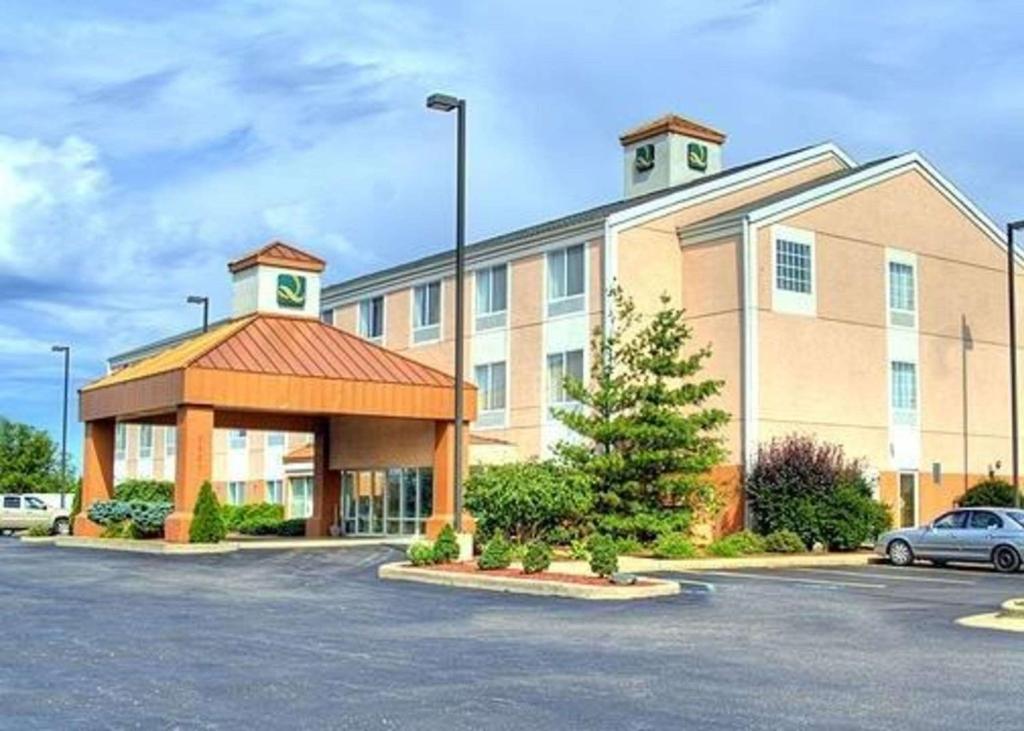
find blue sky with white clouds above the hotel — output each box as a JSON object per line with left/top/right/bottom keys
{"left": 0, "top": 0, "right": 1024, "bottom": 466}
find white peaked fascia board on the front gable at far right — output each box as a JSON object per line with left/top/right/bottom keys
{"left": 748, "top": 153, "right": 1024, "bottom": 258}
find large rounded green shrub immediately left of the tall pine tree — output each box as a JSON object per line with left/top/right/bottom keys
{"left": 466, "top": 462, "right": 591, "bottom": 543}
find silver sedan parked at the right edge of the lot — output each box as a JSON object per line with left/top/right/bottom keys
{"left": 874, "top": 508, "right": 1024, "bottom": 573}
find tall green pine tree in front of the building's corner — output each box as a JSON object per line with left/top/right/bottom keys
{"left": 554, "top": 288, "right": 729, "bottom": 542}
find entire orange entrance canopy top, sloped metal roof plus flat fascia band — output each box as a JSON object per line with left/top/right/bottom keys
{"left": 80, "top": 314, "right": 476, "bottom": 421}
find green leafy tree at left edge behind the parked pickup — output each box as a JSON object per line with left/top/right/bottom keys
{"left": 0, "top": 417, "right": 75, "bottom": 492}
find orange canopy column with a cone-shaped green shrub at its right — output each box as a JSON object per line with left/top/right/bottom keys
{"left": 164, "top": 405, "right": 213, "bottom": 544}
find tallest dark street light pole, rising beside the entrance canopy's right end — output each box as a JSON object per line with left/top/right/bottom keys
{"left": 427, "top": 94, "right": 466, "bottom": 532}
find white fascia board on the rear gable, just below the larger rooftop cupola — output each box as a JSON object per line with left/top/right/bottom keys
{"left": 608, "top": 142, "right": 856, "bottom": 227}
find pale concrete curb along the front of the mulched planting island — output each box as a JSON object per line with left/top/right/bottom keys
{"left": 377, "top": 561, "right": 681, "bottom": 601}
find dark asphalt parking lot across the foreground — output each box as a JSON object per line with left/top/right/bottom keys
{"left": 0, "top": 539, "right": 1024, "bottom": 729}
